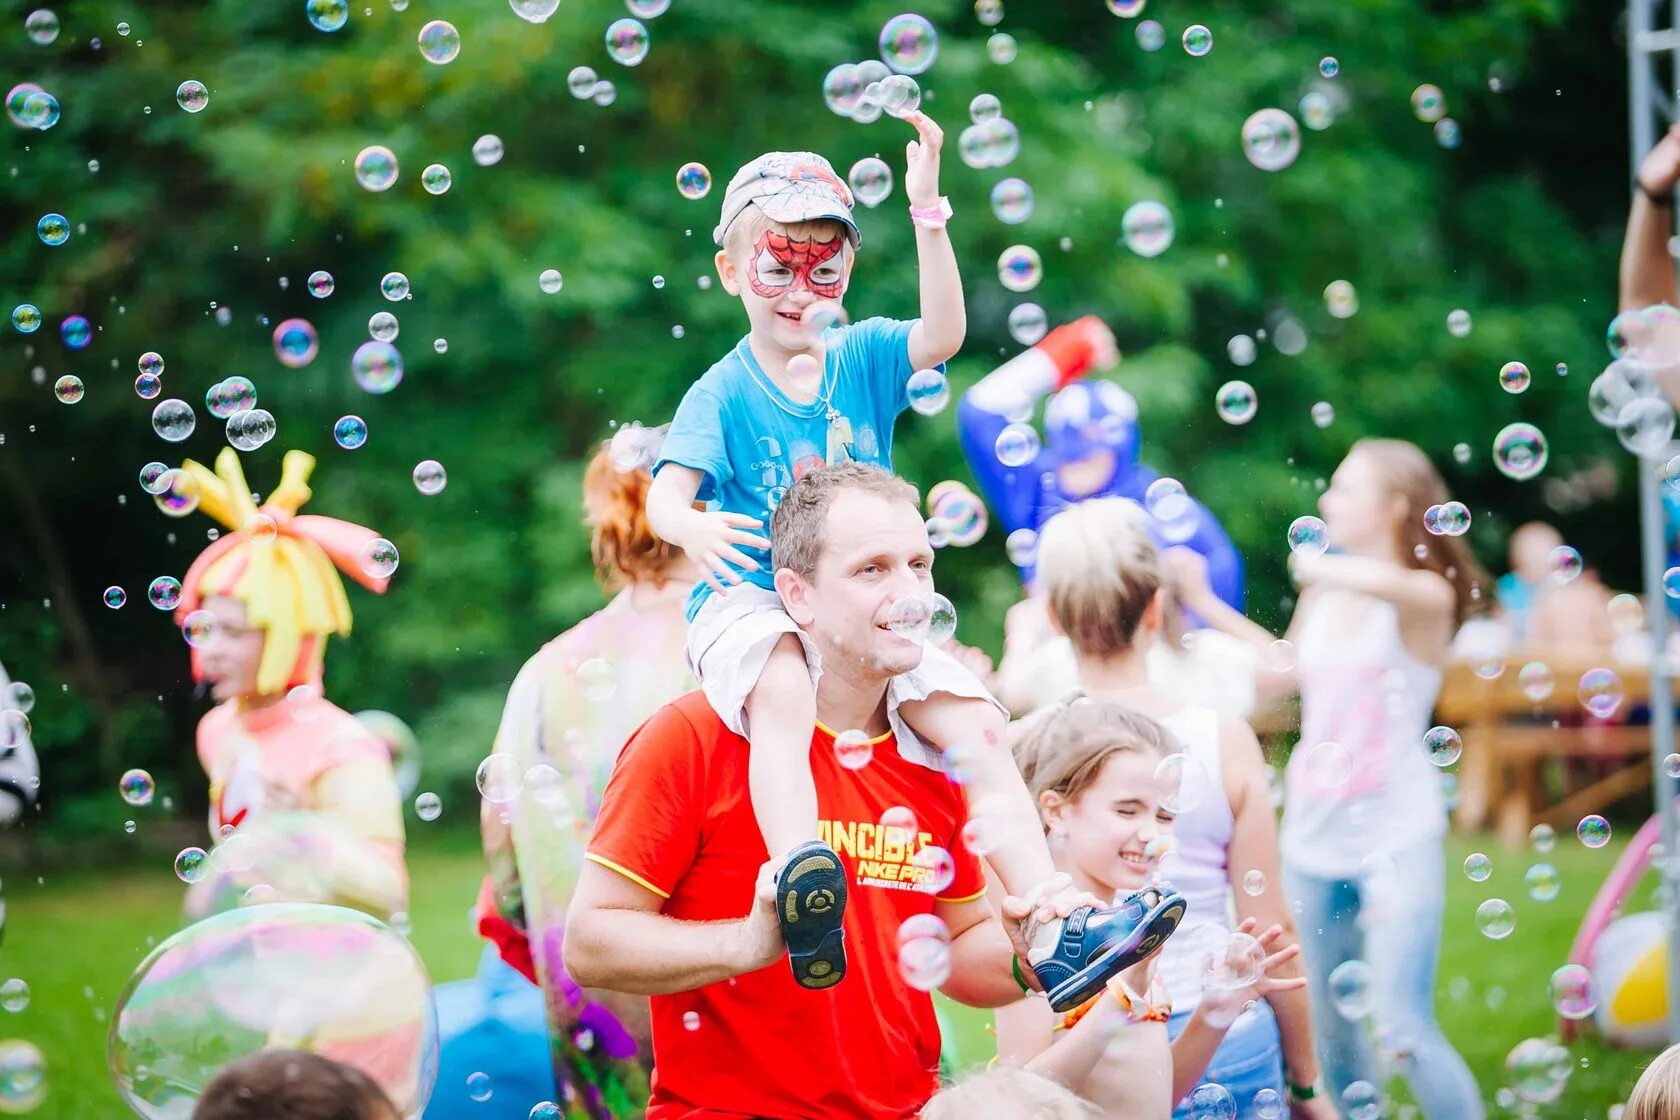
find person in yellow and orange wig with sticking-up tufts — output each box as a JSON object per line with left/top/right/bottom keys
{"left": 173, "top": 448, "right": 408, "bottom": 919}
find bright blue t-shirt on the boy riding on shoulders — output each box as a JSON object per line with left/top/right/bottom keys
{"left": 654, "top": 319, "right": 916, "bottom": 620}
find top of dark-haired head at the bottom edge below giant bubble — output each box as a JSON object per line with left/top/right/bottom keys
{"left": 193, "top": 1049, "right": 400, "bottom": 1120}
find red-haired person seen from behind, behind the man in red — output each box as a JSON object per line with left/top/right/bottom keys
{"left": 428, "top": 427, "right": 697, "bottom": 1120}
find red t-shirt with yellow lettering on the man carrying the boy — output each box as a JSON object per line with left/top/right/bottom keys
{"left": 588, "top": 692, "right": 984, "bottom": 1120}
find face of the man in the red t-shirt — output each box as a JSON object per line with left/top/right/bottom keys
{"left": 785, "top": 489, "right": 934, "bottom": 680}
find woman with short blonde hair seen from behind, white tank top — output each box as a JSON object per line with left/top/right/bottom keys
{"left": 1038, "top": 499, "right": 1336, "bottom": 1118}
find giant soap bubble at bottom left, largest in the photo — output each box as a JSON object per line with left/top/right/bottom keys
{"left": 106, "top": 903, "right": 437, "bottom": 1120}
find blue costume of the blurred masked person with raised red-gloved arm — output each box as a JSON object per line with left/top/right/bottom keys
{"left": 956, "top": 383, "right": 1243, "bottom": 611}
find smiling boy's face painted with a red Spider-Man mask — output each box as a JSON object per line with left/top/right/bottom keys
{"left": 717, "top": 230, "right": 852, "bottom": 353}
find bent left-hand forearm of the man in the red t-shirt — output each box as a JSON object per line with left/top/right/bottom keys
{"left": 563, "top": 908, "right": 761, "bottom": 996}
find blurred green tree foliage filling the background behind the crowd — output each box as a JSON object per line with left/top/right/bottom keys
{"left": 0, "top": 0, "right": 1633, "bottom": 830}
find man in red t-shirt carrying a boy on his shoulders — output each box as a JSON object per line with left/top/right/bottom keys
{"left": 564, "top": 465, "right": 1041, "bottom": 1120}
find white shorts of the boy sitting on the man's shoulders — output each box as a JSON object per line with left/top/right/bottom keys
{"left": 685, "top": 583, "right": 1008, "bottom": 771}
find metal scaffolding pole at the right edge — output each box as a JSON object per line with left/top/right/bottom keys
{"left": 1628, "top": 0, "right": 1680, "bottom": 1043}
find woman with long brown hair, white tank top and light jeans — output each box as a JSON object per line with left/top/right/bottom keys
{"left": 1182, "top": 440, "right": 1483, "bottom": 1120}
